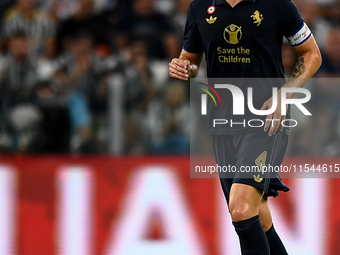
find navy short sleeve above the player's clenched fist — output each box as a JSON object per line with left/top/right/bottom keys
{"left": 183, "top": 6, "right": 204, "bottom": 54}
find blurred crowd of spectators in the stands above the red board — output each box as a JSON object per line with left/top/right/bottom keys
{"left": 0, "top": 0, "right": 340, "bottom": 156}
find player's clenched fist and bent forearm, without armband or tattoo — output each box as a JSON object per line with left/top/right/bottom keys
{"left": 169, "top": 49, "right": 203, "bottom": 81}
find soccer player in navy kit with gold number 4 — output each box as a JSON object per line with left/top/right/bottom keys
{"left": 169, "top": 0, "right": 321, "bottom": 255}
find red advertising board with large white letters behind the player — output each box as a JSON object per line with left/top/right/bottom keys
{"left": 0, "top": 156, "right": 340, "bottom": 255}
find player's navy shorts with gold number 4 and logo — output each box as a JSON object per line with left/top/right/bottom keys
{"left": 213, "top": 130, "right": 289, "bottom": 202}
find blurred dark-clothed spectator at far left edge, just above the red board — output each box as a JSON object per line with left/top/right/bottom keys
{"left": 0, "top": 31, "right": 40, "bottom": 151}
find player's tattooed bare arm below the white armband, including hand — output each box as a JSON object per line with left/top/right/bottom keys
{"left": 261, "top": 35, "right": 322, "bottom": 136}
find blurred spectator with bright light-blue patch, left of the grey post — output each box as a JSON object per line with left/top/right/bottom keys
{"left": 50, "top": 31, "right": 122, "bottom": 153}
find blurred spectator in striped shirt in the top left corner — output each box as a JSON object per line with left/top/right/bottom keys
{"left": 3, "top": 0, "right": 55, "bottom": 59}
